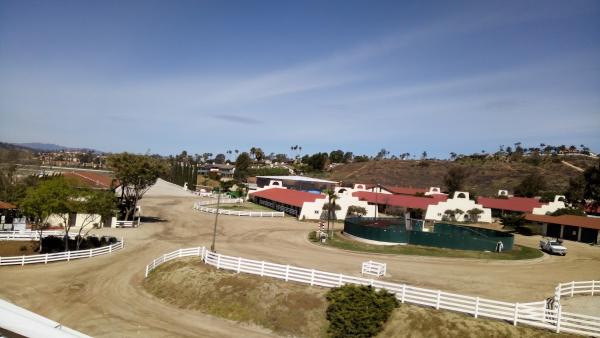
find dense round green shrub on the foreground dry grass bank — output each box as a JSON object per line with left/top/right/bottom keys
{"left": 327, "top": 285, "right": 398, "bottom": 338}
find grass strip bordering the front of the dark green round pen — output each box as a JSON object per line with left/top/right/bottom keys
{"left": 308, "top": 231, "right": 544, "bottom": 260}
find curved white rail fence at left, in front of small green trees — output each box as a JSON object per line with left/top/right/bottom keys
{"left": 0, "top": 238, "right": 124, "bottom": 266}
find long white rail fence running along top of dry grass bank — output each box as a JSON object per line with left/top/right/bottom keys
{"left": 145, "top": 247, "right": 600, "bottom": 336}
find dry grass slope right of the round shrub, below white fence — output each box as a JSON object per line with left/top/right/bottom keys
{"left": 377, "top": 304, "right": 571, "bottom": 338}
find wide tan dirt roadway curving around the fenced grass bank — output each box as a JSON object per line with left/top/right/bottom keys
{"left": 0, "top": 182, "right": 600, "bottom": 337}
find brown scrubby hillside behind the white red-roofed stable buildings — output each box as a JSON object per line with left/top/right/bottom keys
{"left": 328, "top": 156, "right": 598, "bottom": 196}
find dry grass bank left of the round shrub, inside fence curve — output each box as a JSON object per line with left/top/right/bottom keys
{"left": 144, "top": 259, "right": 327, "bottom": 337}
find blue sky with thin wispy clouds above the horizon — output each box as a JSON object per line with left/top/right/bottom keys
{"left": 0, "top": 0, "right": 600, "bottom": 157}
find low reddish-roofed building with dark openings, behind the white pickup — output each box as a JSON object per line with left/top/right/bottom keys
{"left": 525, "top": 214, "right": 600, "bottom": 244}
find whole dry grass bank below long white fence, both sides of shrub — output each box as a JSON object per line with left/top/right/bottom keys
{"left": 144, "top": 258, "right": 570, "bottom": 338}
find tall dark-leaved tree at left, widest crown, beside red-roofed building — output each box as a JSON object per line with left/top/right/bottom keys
{"left": 108, "top": 153, "right": 167, "bottom": 220}
